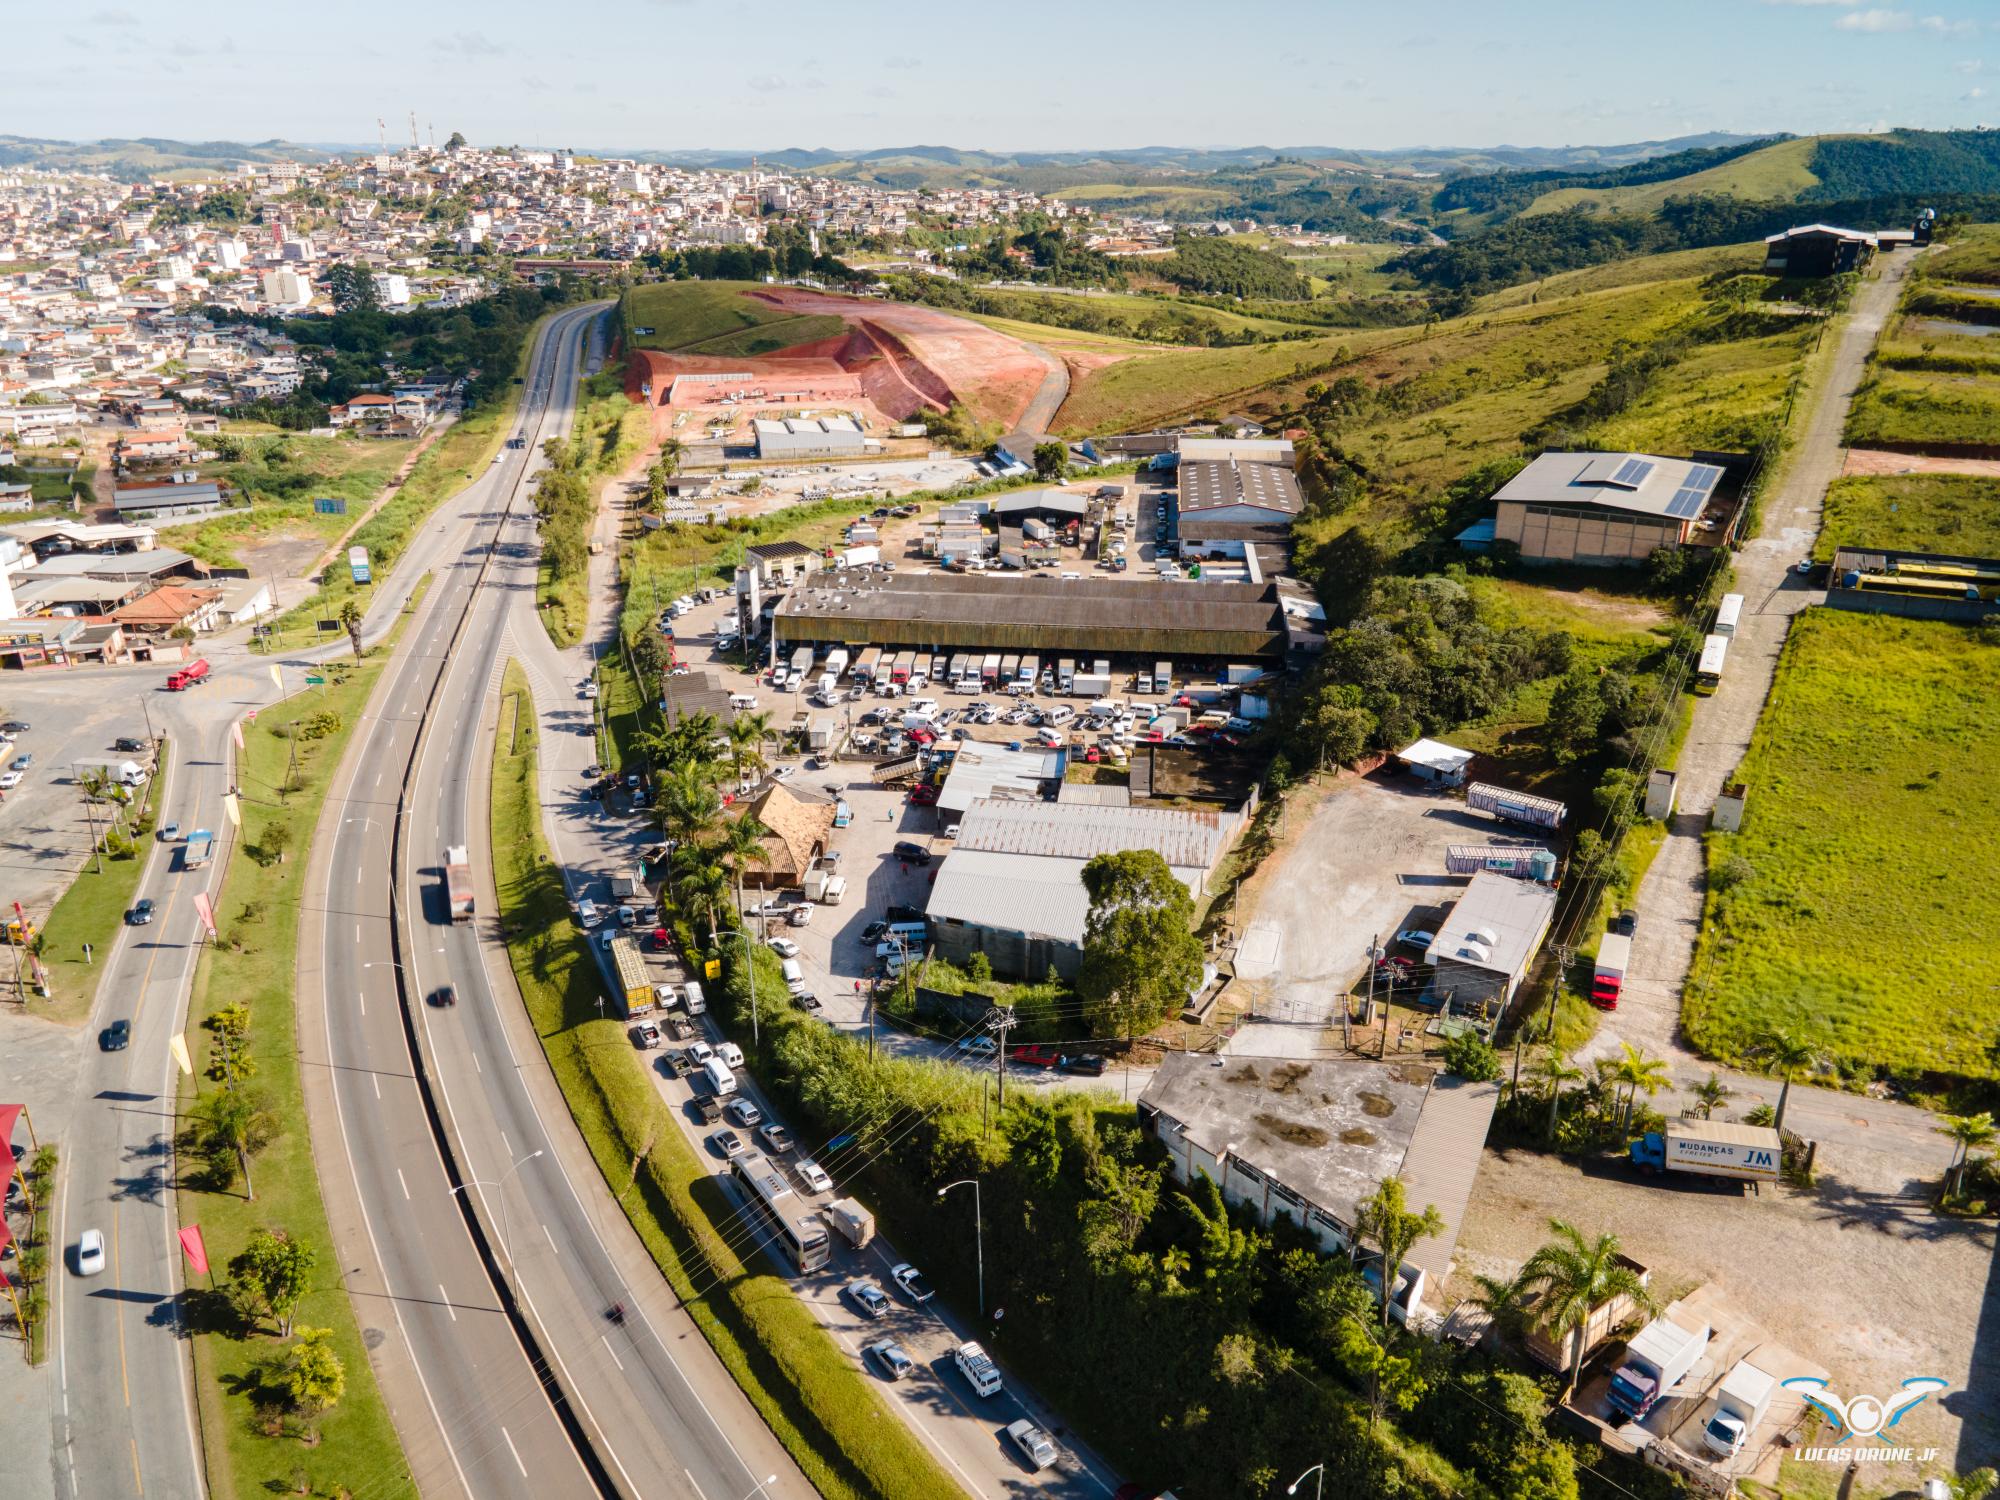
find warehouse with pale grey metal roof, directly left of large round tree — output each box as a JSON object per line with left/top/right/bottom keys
{"left": 926, "top": 798, "right": 1244, "bottom": 980}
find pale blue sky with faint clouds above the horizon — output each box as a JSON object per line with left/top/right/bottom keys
{"left": 0, "top": 0, "right": 2000, "bottom": 152}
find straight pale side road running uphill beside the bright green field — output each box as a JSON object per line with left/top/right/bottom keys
{"left": 1578, "top": 256, "right": 1950, "bottom": 1190}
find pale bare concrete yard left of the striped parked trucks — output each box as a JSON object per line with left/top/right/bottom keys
{"left": 1234, "top": 764, "right": 1514, "bottom": 1024}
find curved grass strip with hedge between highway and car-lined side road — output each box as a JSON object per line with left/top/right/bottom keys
{"left": 492, "top": 662, "right": 956, "bottom": 1500}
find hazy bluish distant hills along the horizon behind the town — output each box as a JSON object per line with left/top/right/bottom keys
{"left": 0, "top": 132, "right": 1750, "bottom": 186}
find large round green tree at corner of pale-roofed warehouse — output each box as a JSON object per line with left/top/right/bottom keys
{"left": 1076, "top": 850, "right": 1202, "bottom": 1036}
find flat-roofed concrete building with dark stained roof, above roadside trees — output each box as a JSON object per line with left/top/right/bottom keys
{"left": 1138, "top": 1052, "right": 1500, "bottom": 1322}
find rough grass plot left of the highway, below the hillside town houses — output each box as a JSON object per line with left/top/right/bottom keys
{"left": 160, "top": 432, "right": 416, "bottom": 568}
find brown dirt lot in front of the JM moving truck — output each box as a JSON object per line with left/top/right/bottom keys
{"left": 1444, "top": 1150, "right": 2000, "bottom": 1470}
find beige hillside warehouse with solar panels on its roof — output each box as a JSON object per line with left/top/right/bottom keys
{"left": 1494, "top": 454, "right": 1736, "bottom": 566}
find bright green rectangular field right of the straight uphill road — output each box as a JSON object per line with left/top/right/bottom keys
{"left": 1684, "top": 610, "right": 2000, "bottom": 1080}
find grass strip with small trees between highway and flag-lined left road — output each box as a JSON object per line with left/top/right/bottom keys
{"left": 180, "top": 612, "right": 422, "bottom": 1500}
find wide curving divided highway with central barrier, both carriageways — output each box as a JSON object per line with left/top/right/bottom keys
{"left": 302, "top": 314, "right": 810, "bottom": 1500}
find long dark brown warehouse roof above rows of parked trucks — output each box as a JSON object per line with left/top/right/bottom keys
{"left": 772, "top": 572, "right": 1286, "bottom": 660}
